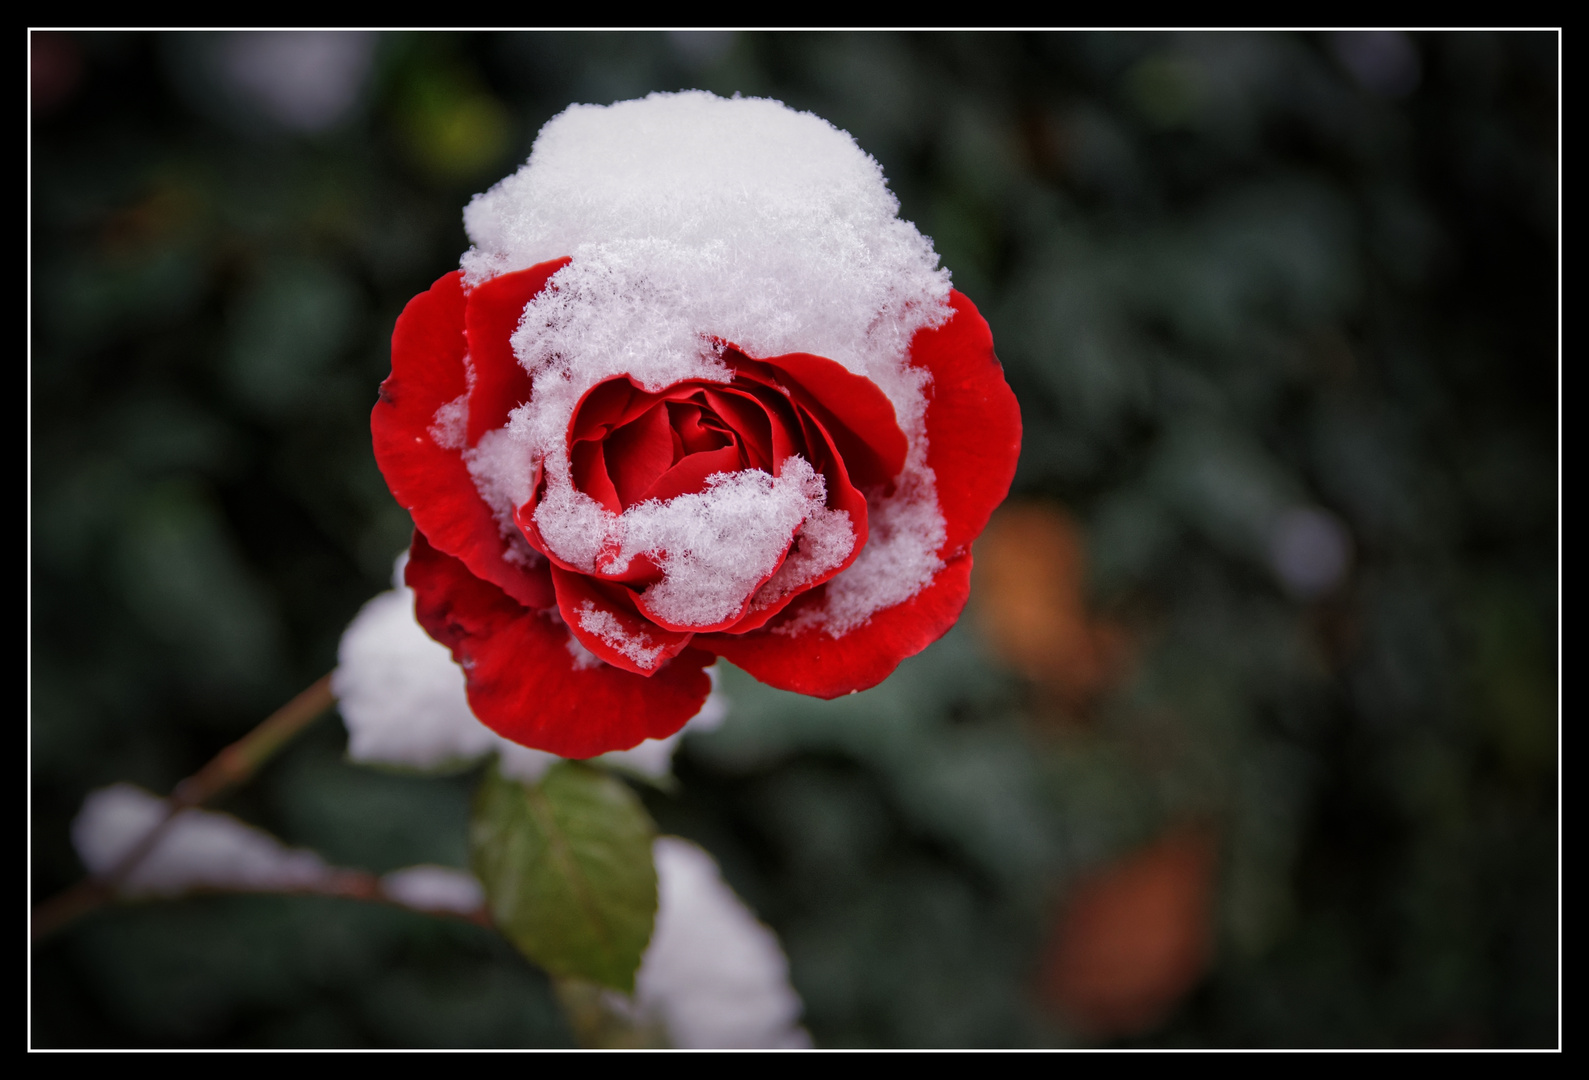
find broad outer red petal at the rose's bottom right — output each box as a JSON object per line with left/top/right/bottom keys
{"left": 694, "top": 554, "right": 971, "bottom": 697}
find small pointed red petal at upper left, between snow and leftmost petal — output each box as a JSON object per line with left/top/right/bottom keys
{"left": 464, "top": 259, "right": 569, "bottom": 446}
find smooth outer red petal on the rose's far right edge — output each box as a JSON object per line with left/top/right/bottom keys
{"left": 910, "top": 291, "right": 1020, "bottom": 559}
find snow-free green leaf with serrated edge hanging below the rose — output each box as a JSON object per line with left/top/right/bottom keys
{"left": 469, "top": 761, "right": 656, "bottom": 993}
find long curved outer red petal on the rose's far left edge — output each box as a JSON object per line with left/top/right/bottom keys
{"left": 370, "top": 272, "right": 555, "bottom": 607}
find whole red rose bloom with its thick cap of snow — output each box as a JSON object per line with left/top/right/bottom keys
{"left": 372, "top": 92, "right": 1020, "bottom": 758}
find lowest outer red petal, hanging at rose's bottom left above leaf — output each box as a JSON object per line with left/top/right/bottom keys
{"left": 405, "top": 535, "right": 712, "bottom": 758}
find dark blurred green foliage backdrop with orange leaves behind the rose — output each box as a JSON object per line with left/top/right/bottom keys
{"left": 29, "top": 33, "right": 1560, "bottom": 1047}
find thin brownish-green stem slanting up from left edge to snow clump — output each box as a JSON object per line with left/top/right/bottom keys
{"left": 33, "top": 675, "right": 335, "bottom": 940}
